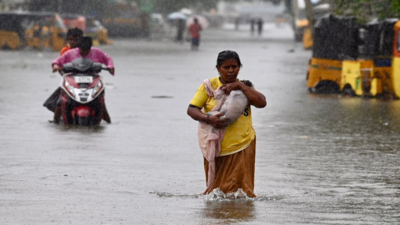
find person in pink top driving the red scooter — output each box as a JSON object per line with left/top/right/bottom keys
{"left": 52, "top": 36, "right": 115, "bottom": 123}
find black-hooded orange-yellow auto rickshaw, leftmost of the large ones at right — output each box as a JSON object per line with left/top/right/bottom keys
{"left": 307, "top": 14, "right": 358, "bottom": 93}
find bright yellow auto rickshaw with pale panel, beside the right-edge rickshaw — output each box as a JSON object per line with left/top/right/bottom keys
{"left": 341, "top": 19, "right": 397, "bottom": 97}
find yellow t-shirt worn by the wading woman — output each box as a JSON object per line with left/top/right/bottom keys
{"left": 190, "top": 77, "right": 255, "bottom": 156}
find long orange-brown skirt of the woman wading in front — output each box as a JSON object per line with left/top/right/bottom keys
{"left": 204, "top": 138, "right": 256, "bottom": 197}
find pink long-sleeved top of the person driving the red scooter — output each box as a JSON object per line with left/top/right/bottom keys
{"left": 51, "top": 47, "right": 114, "bottom": 75}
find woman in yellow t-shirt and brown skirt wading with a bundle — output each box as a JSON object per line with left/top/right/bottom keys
{"left": 187, "top": 50, "right": 267, "bottom": 197}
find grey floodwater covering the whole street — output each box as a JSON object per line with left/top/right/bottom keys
{"left": 0, "top": 24, "right": 400, "bottom": 225}
